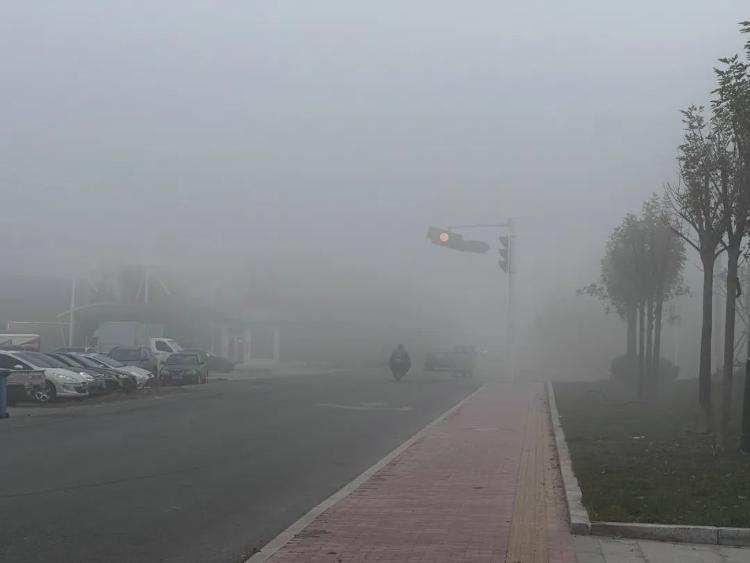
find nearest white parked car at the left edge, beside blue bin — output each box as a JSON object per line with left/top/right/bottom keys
{"left": 0, "top": 350, "right": 95, "bottom": 403}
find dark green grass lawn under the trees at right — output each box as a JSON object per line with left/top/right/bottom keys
{"left": 554, "top": 380, "right": 750, "bottom": 527}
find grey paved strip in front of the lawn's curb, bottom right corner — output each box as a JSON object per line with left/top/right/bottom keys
{"left": 575, "top": 536, "right": 750, "bottom": 563}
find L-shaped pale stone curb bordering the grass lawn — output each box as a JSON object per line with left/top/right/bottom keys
{"left": 547, "top": 381, "right": 750, "bottom": 547}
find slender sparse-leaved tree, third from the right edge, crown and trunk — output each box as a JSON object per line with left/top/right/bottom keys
{"left": 665, "top": 106, "right": 726, "bottom": 430}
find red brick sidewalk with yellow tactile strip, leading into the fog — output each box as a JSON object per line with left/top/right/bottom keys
{"left": 270, "top": 383, "right": 576, "bottom": 563}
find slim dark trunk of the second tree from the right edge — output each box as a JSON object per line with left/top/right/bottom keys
{"left": 719, "top": 245, "right": 740, "bottom": 447}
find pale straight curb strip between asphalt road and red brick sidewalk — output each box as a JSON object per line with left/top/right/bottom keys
{"left": 244, "top": 385, "right": 484, "bottom": 563}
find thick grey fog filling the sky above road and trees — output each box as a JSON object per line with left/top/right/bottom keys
{"left": 0, "top": 0, "right": 747, "bottom": 377}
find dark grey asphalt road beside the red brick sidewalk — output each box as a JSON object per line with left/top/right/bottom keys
{"left": 0, "top": 373, "right": 480, "bottom": 563}
